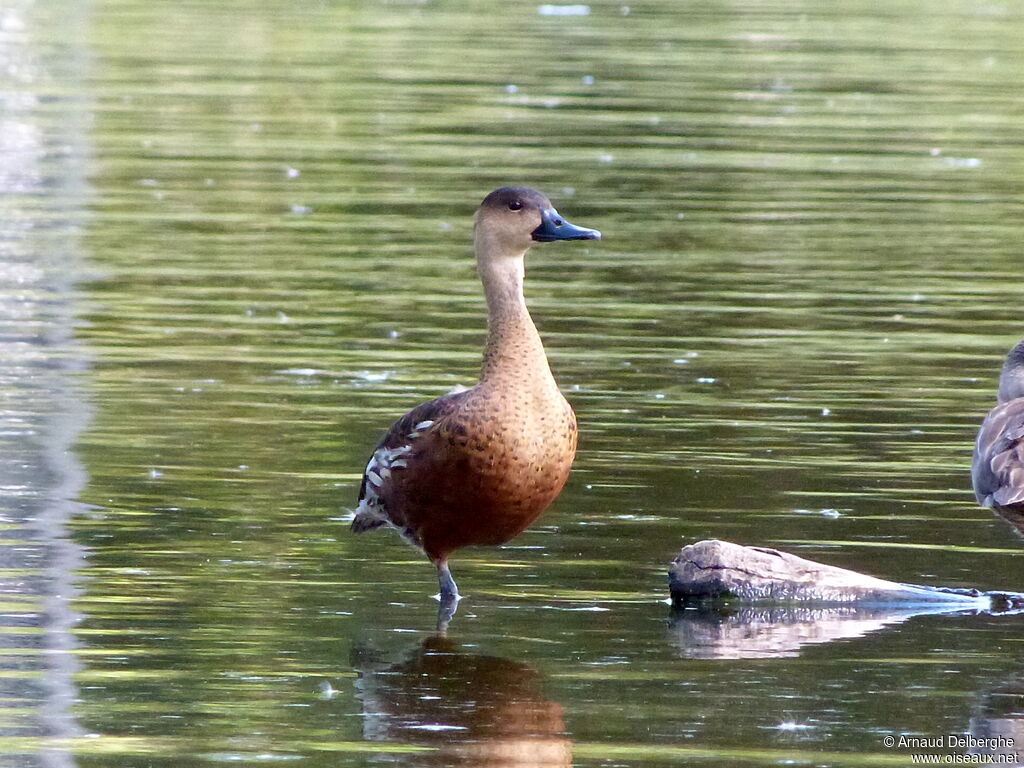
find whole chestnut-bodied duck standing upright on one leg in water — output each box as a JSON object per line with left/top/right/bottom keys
{"left": 351, "top": 186, "right": 601, "bottom": 625}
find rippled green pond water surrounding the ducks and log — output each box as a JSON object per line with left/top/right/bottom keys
{"left": 6, "top": 0, "right": 1024, "bottom": 768}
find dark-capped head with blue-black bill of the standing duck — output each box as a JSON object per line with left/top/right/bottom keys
{"left": 474, "top": 186, "right": 601, "bottom": 256}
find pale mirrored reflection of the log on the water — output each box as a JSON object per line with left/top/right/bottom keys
{"left": 670, "top": 605, "right": 950, "bottom": 658}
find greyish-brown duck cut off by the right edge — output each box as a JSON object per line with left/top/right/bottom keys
{"left": 971, "top": 341, "right": 1024, "bottom": 532}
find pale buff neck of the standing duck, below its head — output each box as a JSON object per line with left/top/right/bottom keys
{"left": 475, "top": 230, "right": 555, "bottom": 386}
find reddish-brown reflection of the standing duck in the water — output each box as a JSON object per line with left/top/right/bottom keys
{"left": 353, "top": 636, "right": 572, "bottom": 768}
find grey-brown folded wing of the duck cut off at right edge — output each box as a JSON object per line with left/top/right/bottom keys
{"left": 971, "top": 397, "right": 1024, "bottom": 509}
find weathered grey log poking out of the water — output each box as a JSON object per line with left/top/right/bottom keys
{"left": 669, "top": 539, "right": 1024, "bottom": 610}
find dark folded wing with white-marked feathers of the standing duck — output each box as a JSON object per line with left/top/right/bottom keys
{"left": 352, "top": 390, "right": 472, "bottom": 532}
